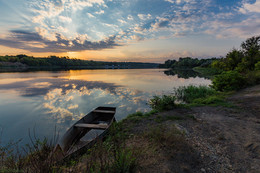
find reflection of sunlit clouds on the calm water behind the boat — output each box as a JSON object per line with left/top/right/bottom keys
{"left": 0, "top": 75, "right": 149, "bottom": 124}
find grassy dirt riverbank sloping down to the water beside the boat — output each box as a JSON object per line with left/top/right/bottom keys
{"left": 2, "top": 85, "right": 260, "bottom": 173}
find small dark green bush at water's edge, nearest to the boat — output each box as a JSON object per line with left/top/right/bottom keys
{"left": 148, "top": 95, "right": 176, "bottom": 111}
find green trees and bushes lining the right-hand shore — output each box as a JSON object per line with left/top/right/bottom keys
{"left": 161, "top": 36, "right": 260, "bottom": 91}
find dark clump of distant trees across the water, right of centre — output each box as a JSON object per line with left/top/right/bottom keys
{"left": 159, "top": 57, "right": 217, "bottom": 69}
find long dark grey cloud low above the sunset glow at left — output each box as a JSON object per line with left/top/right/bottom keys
{"left": 0, "top": 30, "right": 118, "bottom": 52}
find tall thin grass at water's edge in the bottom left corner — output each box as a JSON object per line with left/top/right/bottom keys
{"left": 0, "top": 128, "right": 58, "bottom": 173}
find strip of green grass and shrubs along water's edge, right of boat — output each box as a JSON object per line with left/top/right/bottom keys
{"left": 144, "top": 85, "right": 233, "bottom": 113}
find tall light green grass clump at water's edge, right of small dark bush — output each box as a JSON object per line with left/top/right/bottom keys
{"left": 174, "top": 85, "right": 217, "bottom": 103}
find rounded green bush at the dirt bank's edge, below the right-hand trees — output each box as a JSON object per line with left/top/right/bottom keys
{"left": 212, "top": 71, "right": 246, "bottom": 91}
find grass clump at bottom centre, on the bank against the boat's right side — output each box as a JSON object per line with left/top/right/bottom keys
{"left": 75, "top": 124, "right": 137, "bottom": 173}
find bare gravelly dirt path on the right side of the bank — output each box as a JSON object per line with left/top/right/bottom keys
{"left": 178, "top": 85, "right": 260, "bottom": 172}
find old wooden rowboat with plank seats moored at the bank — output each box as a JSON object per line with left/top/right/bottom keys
{"left": 53, "top": 107, "right": 116, "bottom": 160}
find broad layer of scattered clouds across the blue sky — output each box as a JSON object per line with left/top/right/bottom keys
{"left": 0, "top": 0, "right": 260, "bottom": 55}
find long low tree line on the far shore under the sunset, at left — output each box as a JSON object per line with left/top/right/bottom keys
{"left": 0, "top": 54, "right": 158, "bottom": 68}
